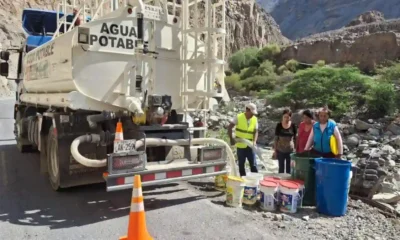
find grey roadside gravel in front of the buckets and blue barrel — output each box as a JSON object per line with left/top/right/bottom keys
{"left": 188, "top": 179, "right": 400, "bottom": 240}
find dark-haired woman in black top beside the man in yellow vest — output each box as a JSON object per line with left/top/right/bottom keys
{"left": 274, "top": 109, "right": 297, "bottom": 173}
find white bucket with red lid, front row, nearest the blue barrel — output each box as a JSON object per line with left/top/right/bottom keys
{"left": 279, "top": 180, "right": 299, "bottom": 213}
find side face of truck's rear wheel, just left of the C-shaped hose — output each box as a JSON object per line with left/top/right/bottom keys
{"left": 47, "top": 126, "right": 61, "bottom": 191}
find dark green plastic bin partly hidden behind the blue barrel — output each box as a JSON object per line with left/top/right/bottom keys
{"left": 290, "top": 152, "right": 319, "bottom": 206}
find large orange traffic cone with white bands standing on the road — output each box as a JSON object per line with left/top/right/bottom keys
{"left": 119, "top": 175, "right": 153, "bottom": 240}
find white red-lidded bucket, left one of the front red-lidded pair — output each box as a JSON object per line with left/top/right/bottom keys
{"left": 260, "top": 181, "right": 278, "bottom": 211}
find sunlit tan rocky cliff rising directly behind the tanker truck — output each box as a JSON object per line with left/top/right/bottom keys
{"left": 0, "top": 0, "right": 289, "bottom": 55}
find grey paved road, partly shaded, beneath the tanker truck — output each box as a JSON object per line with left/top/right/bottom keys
{"left": 0, "top": 100, "right": 275, "bottom": 240}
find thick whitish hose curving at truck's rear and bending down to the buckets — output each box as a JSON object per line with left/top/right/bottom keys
{"left": 71, "top": 134, "right": 238, "bottom": 176}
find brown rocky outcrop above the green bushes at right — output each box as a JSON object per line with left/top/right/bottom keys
{"left": 280, "top": 12, "right": 400, "bottom": 71}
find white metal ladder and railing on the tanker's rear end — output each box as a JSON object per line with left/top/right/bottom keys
{"left": 180, "top": 0, "right": 226, "bottom": 132}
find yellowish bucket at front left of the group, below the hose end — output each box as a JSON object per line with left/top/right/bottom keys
{"left": 226, "top": 176, "right": 245, "bottom": 207}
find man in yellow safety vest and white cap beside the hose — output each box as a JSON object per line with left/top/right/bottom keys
{"left": 228, "top": 103, "right": 258, "bottom": 176}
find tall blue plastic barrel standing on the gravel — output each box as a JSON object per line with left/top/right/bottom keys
{"left": 315, "top": 158, "right": 351, "bottom": 217}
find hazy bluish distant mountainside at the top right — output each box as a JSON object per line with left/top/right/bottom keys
{"left": 258, "top": 0, "right": 400, "bottom": 39}
